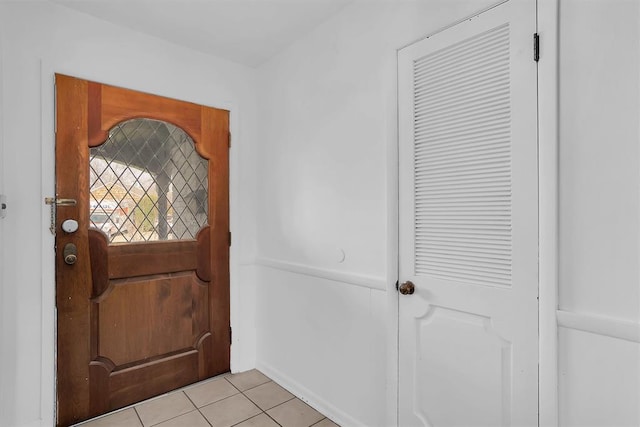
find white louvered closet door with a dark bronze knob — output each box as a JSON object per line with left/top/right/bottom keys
{"left": 398, "top": 0, "right": 538, "bottom": 427}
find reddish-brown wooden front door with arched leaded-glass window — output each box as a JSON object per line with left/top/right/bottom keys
{"left": 55, "top": 75, "right": 230, "bottom": 425}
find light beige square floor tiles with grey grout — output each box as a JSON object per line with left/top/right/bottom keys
{"left": 77, "top": 369, "right": 338, "bottom": 427}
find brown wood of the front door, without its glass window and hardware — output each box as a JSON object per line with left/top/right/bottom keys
{"left": 56, "top": 75, "right": 230, "bottom": 425}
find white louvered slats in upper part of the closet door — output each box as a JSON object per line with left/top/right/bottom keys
{"left": 413, "top": 24, "right": 512, "bottom": 286}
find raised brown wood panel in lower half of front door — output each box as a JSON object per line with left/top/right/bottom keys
{"left": 93, "top": 272, "right": 208, "bottom": 366}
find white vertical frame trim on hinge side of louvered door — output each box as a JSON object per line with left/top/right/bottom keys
{"left": 537, "top": 0, "right": 560, "bottom": 427}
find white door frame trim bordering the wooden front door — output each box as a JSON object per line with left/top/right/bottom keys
{"left": 40, "top": 64, "right": 244, "bottom": 426}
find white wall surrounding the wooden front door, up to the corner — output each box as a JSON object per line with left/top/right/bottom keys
{"left": 0, "top": 2, "right": 256, "bottom": 426}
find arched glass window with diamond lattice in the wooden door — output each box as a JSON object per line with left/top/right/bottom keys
{"left": 89, "top": 118, "right": 208, "bottom": 243}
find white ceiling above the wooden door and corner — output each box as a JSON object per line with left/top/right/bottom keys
{"left": 51, "top": 0, "right": 353, "bottom": 67}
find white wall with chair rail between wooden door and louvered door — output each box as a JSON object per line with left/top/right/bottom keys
{"left": 252, "top": 1, "right": 494, "bottom": 426}
